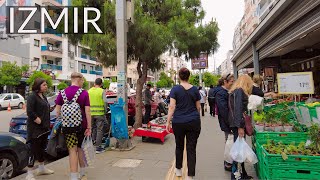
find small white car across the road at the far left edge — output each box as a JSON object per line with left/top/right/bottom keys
{"left": 0, "top": 93, "right": 25, "bottom": 110}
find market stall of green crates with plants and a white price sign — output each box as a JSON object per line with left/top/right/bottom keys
{"left": 252, "top": 72, "right": 320, "bottom": 179}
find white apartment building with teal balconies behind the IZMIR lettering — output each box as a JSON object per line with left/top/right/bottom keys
{"left": 0, "top": 0, "right": 103, "bottom": 90}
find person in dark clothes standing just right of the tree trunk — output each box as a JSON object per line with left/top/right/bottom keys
{"left": 142, "top": 84, "right": 153, "bottom": 142}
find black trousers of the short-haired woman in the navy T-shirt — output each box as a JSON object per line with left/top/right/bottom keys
{"left": 172, "top": 119, "right": 201, "bottom": 176}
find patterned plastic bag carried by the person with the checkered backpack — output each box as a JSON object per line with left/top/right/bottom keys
{"left": 81, "top": 136, "right": 96, "bottom": 167}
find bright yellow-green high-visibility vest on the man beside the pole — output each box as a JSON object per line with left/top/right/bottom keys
{"left": 88, "top": 87, "right": 105, "bottom": 116}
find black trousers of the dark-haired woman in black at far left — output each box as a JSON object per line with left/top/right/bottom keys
{"left": 28, "top": 135, "right": 48, "bottom": 168}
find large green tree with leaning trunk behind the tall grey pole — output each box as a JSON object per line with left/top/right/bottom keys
{"left": 69, "top": 0, "right": 219, "bottom": 128}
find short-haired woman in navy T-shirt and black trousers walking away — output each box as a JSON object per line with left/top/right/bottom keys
{"left": 167, "top": 68, "right": 201, "bottom": 179}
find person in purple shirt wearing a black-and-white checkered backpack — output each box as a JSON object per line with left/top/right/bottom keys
{"left": 56, "top": 72, "right": 91, "bottom": 180}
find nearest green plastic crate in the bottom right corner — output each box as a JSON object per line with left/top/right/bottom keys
{"left": 256, "top": 142, "right": 320, "bottom": 180}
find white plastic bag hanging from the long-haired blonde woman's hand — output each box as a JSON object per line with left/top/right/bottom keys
{"left": 230, "top": 137, "right": 258, "bottom": 164}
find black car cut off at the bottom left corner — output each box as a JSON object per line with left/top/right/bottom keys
{"left": 0, "top": 132, "right": 30, "bottom": 179}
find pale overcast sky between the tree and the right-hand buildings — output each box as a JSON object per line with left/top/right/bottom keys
{"left": 195, "top": 0, "right": 244, "bottom": 71}
